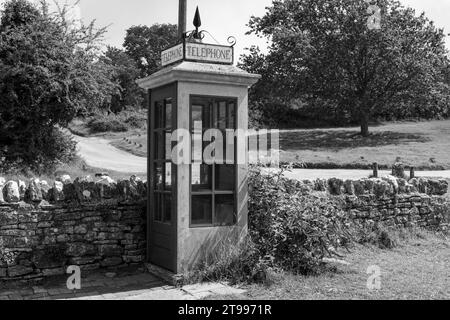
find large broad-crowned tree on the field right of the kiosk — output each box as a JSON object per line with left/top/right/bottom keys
{"left": 241, "top": 0, "right": 449, "bottom": 136}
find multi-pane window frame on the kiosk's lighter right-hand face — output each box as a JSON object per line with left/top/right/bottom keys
{"left": 189, "top": 95, "right": 239, "bottom": 229}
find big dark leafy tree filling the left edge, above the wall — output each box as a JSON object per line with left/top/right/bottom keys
{"left": 0, "top": 0, "right": 116, "bottom": 172}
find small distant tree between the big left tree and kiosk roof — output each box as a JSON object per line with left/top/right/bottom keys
{"left": 103, "top": 47, "right": 145, "bottom": 113}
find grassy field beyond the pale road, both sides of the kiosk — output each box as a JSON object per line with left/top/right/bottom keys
{"left": 72, "top": 120, "right": 450, "bottom": 170}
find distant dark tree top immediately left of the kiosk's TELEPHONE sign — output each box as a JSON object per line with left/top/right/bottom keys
{"left": 123, "top": 24, "right": 178, "bottom": 77}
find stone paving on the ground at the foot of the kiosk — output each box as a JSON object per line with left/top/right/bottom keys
{"left": 0, "top": 272, "right": 245, "bottom": 300}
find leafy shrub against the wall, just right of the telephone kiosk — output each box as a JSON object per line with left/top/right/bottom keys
{"left": 249, "top": 169, "right": 351, "bottom": 275}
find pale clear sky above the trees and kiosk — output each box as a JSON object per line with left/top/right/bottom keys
{"left": 0, "top": 0, "right": 450, "bottom": 56}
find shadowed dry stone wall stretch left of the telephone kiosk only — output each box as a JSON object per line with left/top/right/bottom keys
{"left": 0, "top": 177, "right": 146, "bottom": 280}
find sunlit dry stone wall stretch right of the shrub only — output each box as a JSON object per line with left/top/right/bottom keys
{"left": 297, "top": 176, "right": 450, "bottom": 231}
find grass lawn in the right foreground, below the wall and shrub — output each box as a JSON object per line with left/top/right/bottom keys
{"left": 211, "top": 235, "right": 450, "bottom": 300}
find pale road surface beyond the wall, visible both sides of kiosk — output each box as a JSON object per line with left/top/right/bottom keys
{"left": 74, "top": 136, "right": 450, "bottom": 180}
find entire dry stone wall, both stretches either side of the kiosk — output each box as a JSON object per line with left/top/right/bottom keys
{"left": 0, "top": 172, "right": 449, "bottom": 281}
